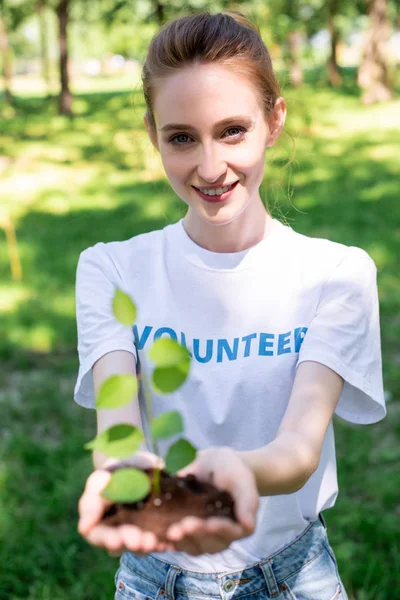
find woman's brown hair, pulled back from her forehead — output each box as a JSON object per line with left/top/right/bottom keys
{"left": 142, "top": 11, "right": 280, "bottom": 129}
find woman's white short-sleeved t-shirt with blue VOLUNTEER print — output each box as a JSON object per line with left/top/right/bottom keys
{"left": 74, "top": 219, "right": 386, "bottom": 572}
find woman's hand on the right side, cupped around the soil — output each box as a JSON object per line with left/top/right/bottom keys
{"left": 167, "top": 446, "right": 259, "bottom": 556}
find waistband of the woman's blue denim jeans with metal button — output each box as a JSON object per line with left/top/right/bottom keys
{"left": 121, "top": 514, "right": 327, "bottom": 600}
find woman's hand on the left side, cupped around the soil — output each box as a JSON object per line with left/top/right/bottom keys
{"left": 78, "top": 451, "right": 175, "bottom": 556}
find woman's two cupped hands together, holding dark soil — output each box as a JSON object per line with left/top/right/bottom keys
{"left": 78, "top": 446, "right": 259, "bottom": 557}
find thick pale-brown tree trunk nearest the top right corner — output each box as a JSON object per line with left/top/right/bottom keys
{"left": 358, "top": 0, "right": 393, "bottom": 104}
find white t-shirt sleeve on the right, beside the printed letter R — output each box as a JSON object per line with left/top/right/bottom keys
{"left": 297, "top": 246, "right": 386, "bottom": 424}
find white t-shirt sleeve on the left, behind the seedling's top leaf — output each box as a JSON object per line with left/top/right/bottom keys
{"left": 74, "top": 243, "right": 137, "bottom": 408}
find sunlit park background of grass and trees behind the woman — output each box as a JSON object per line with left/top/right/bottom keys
{"left": 0, "top": 0, "right": 400, "bottom": 600}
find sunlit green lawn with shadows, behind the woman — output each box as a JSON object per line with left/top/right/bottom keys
{"left": 0, "top": 71, "right": 400, "bottom": 600}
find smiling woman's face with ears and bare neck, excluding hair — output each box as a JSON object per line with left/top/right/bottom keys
{"left": 144, "top": 61, "right": 286, "bottom": 252}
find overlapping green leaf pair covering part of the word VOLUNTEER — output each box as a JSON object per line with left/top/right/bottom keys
{"left": 149, "top": 338, "right": 190, "bottom": 394}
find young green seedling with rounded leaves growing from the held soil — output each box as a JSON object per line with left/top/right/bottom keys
{"left": 84, "top": 289, "right": 197, "bottom": 503}
